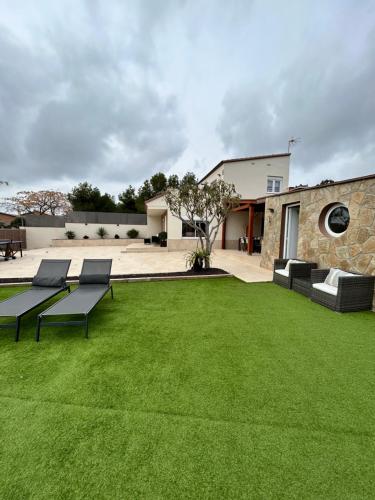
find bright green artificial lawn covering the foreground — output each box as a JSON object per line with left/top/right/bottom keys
{"left": 0, "top": 278, "right": 375, "bottom": 499}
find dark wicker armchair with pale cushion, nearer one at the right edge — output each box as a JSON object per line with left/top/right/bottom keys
{"left": 311, "top": 269, "right": 375, "bottom": 312}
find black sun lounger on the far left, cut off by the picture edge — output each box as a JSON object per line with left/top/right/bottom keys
{"left": 0, "top": 259, "right": 70, "bottom": 342}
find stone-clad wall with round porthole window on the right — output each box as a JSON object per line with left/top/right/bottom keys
{"left": 261, "top": 178, "right": 375, "bottom": 305}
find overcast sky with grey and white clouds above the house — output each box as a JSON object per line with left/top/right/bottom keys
{"left": 0, "top": 0, "right": 375, "bottom": 199}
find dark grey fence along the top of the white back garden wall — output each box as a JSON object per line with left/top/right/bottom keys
{"left": 22, "top": 212, "right": 147, "bottom": 227}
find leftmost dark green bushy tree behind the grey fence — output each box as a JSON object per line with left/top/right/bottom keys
{"left": 68, "top": 182, "right": 116, "bottom": 212}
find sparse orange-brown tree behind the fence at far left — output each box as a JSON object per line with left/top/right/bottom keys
{"left": 7, "top": 191, "right": 71, "bottom": 215}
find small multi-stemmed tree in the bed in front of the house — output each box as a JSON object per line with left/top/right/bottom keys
{"left": 165, "top": 172, "right": 240, "bottom": 267}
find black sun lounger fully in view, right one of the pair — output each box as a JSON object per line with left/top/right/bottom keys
{"left": 35, "top": 259, "right": 113, "bottom": 342}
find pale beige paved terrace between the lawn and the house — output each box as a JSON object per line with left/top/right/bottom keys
{"left": 0, "top": 246, "right": 272, "bottom": 282}
